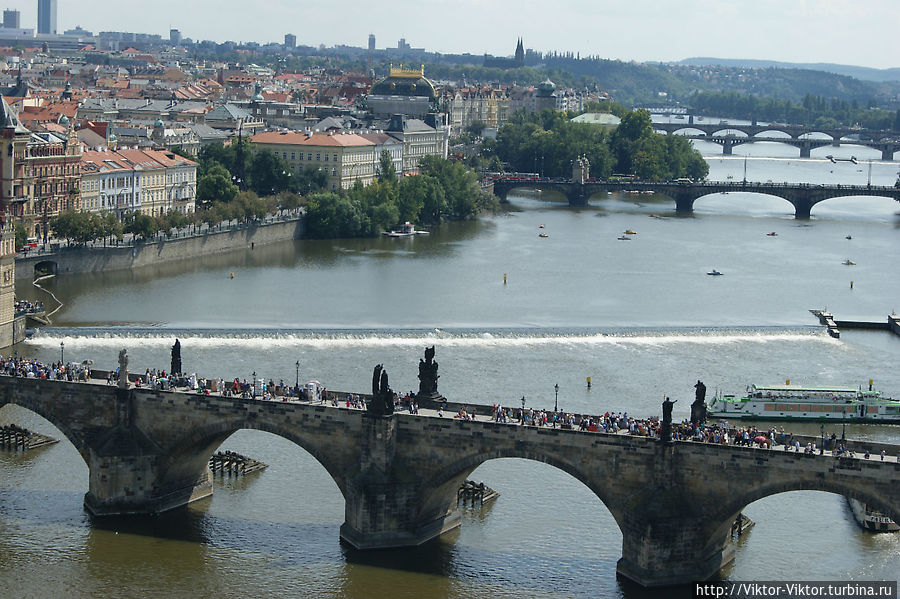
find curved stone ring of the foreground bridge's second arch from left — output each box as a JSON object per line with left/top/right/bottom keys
{"left": 155, "top": 419, "right": 347, "bottom": 498}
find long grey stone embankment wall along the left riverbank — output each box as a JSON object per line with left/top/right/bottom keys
{"left": 15, "top": 216, "right": 306, "bottom": 281}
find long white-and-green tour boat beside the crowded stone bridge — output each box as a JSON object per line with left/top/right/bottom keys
{"left": 709, "top": 382, "right": 900, "bottom": 424}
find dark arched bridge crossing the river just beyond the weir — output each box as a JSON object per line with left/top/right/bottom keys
{"left": 493, "top": 179, "right": 900, "bottom": 218}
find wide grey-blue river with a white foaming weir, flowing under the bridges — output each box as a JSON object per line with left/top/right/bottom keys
{"left": 0, "top": 142, "right": 900, "bottom": 599}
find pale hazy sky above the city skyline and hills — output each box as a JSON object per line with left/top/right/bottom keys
{"left": 4, "top": 0, "right": 900, "bottom": 68}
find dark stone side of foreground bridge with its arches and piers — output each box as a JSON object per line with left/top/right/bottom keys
{"left": 0, "top": 376, "right": 900, "bottom": 586}
